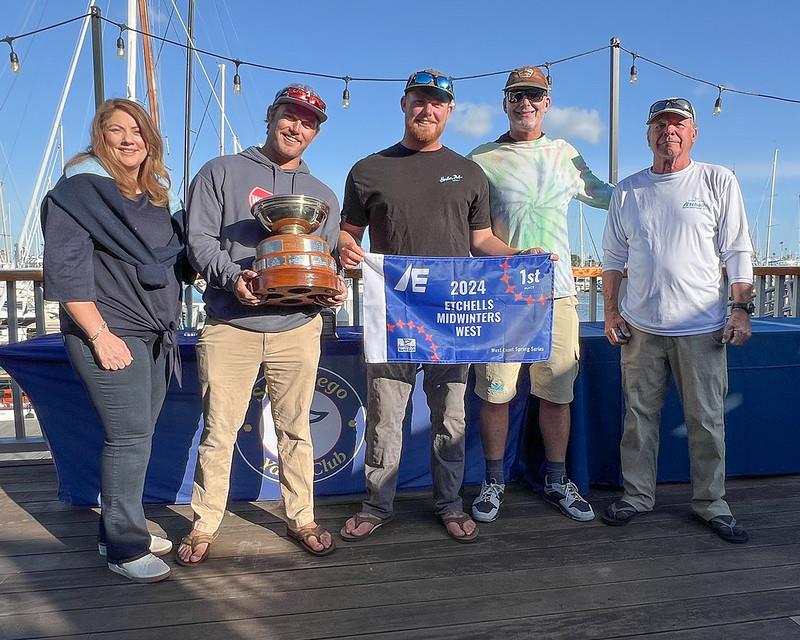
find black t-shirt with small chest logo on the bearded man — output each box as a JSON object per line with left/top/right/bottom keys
{"left": 342, "top": 144, "right": 491, "bottom": 256}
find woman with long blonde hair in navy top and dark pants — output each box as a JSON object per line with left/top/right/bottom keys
{"left": 42, "top": 99, "right": 184, "bottom": 582}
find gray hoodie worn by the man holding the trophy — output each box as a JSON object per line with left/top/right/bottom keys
{"left": 186, "top": 147, "right": 339, "bottom": 333}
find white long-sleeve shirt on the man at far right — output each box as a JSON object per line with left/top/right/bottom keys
{"left": 603, "top": 162, "right": 753, "bottom": 336}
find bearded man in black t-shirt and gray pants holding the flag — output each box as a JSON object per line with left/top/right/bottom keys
{"left": 339, "top": 69, "right": 534, "bottom": 542}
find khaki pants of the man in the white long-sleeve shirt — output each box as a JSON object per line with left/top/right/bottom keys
{"left": 620, "top": 325, "right": 731, "bottom": 520}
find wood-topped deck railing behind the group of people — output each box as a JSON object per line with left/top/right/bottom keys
{"left": 0, "top": 267, "right": 800, "bottom": 453}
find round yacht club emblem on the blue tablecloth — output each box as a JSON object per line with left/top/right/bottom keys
{"left": 236, "top": 367, "right": 366, "bottom": 483}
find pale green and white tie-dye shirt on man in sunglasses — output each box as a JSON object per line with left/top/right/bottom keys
{"left": 467, "top": 133, "right": 613, "bottom": 298}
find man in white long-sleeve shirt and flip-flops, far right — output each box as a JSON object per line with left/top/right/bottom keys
{"left": 603, "top": 98, "right": 753, "bottom": 543}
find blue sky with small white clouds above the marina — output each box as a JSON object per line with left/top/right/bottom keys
{"left": 0, "top": 0, "right": 800, "bottom": 262}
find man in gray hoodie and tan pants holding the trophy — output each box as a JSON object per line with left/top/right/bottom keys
{"left": 176, "top": 84, "right": 347, "bottom": 565}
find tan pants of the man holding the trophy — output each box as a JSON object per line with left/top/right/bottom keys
{"left": 192, "top": 316, "right": 322, "bottom": 533}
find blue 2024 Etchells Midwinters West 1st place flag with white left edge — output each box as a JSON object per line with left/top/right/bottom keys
{"left": 364, "top": 253, "right": 553, "bottom": 363}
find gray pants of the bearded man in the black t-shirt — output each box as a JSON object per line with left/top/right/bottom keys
{"left": 362, "top": 363, "right": 469, "bottom": 518}
